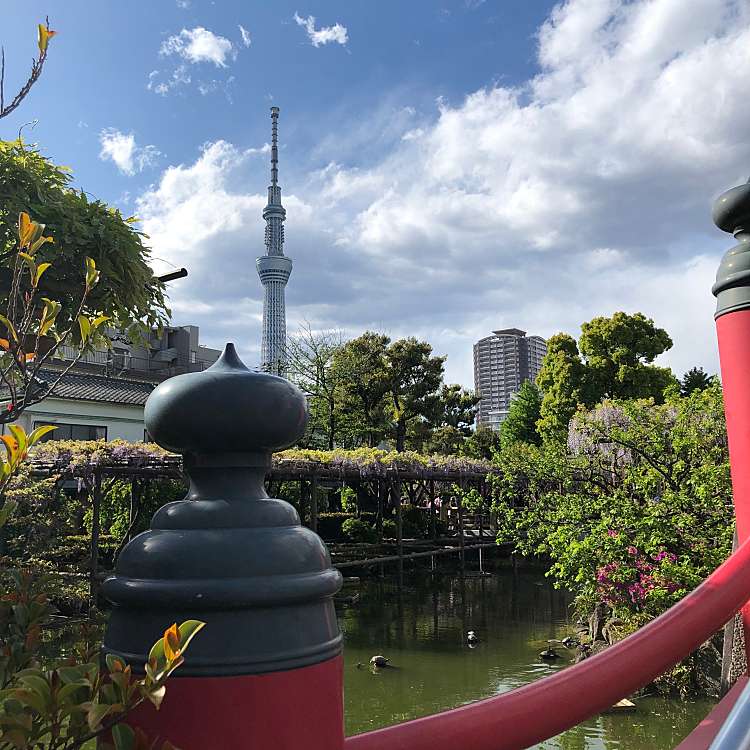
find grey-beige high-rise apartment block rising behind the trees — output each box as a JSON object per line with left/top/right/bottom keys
{"left": 474, "top": 328, "right": 547, "bottom": 430}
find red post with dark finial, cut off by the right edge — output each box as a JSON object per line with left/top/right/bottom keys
{"left": 713, "top": 184, "right": 750, "bottom": 663}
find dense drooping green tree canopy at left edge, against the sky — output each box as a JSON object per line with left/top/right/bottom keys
{"left": 0, "top": 141, "right": 169, "bottom": 335}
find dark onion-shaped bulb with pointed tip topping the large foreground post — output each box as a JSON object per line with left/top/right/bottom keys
{"left": 144, "top": 343, "right": 307, "bottom": 458}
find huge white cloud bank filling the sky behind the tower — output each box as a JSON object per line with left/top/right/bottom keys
{"left": 138, "top": 0, "right": 750, "bottom": 384}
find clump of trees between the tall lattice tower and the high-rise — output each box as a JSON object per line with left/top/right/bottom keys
{"left": 289, "top": 327, "right": 478, "bottom": 453}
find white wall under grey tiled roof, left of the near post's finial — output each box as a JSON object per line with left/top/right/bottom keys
{"left": 10, "top": 398, "right": 145, "bottom": 443}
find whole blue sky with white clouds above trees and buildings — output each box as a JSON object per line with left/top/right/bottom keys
{"left": 0, "top": 0, "right": 750, "bottom": 385}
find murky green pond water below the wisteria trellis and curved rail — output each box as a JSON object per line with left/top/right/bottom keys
{"left": 338, "top": 569, "right": 712, "bottom": 750}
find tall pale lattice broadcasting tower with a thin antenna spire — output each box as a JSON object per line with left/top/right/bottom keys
{"left": 256, "top": 107, "right": 292, "bottom": 376}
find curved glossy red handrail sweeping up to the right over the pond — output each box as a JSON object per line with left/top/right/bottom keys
{"left": 345, "top": 540, "right": 750, "bottom": 750}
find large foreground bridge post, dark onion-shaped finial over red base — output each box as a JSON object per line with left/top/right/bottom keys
{"left": 104, "top": 344, "right": 344, "bottom": 750}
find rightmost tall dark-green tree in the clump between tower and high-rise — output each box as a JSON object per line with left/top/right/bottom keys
{"left": 386, "top": 337, "right": 446, "bottom": 452}
